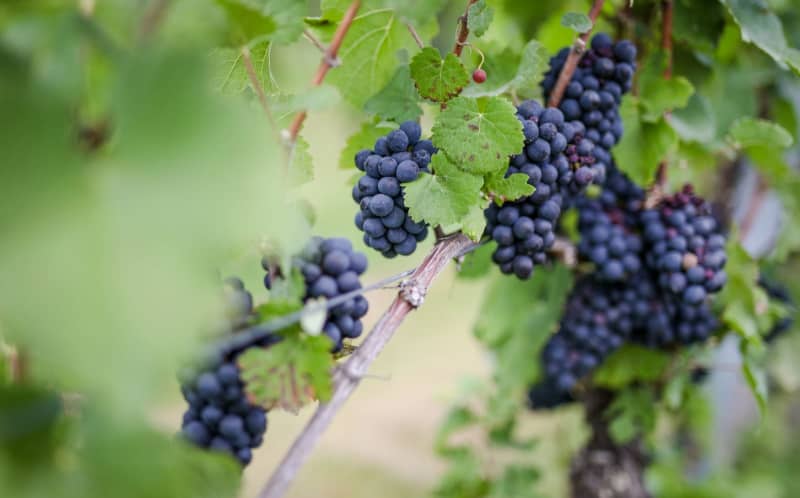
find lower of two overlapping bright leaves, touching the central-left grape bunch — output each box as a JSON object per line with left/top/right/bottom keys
{"left": 404, "top": 154, "right": 483, "bottom": 230}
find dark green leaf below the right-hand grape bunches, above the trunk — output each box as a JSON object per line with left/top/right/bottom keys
{"left": 592, "top": 344, "right": 670, "bottom": 389}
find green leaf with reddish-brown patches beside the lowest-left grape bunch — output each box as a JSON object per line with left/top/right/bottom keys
{"left": 237, "top": 333, "right": 333, "bottom": 413}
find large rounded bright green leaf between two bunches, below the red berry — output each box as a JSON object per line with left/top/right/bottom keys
{"left": 433, "top": 97, "right": 523, "bottom": 174}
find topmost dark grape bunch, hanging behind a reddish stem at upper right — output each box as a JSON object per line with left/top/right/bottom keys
{"left": 542, "top": 33, "right": 636, "bottom": 168}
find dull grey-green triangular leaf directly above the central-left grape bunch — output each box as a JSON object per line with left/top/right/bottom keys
{"left": 364, "top": 65, "right": 422, "bottom": 123}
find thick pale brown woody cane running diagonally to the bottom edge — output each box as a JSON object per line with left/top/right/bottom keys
{"left": 258, "top": 233, "right": 476, "bottom": 498}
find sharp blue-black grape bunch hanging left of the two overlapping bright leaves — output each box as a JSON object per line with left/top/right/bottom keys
{"left": 353, "top": 121, "right": 436, "bottom": 258}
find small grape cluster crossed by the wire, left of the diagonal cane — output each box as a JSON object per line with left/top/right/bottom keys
{"left": 294, "top": 237, "right": 369, "bottom": 353}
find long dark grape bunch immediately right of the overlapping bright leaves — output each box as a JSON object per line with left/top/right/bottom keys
{"left": 485, "top": 100, "right": 605, "bottom": 279}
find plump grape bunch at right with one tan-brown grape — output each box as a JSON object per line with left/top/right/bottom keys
{"left": 640, "top": 185, "right": 727, "bottom": 308}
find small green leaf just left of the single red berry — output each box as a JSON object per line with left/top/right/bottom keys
{"left": 411, "top": 47, "right": 469, "bottom": 102}
